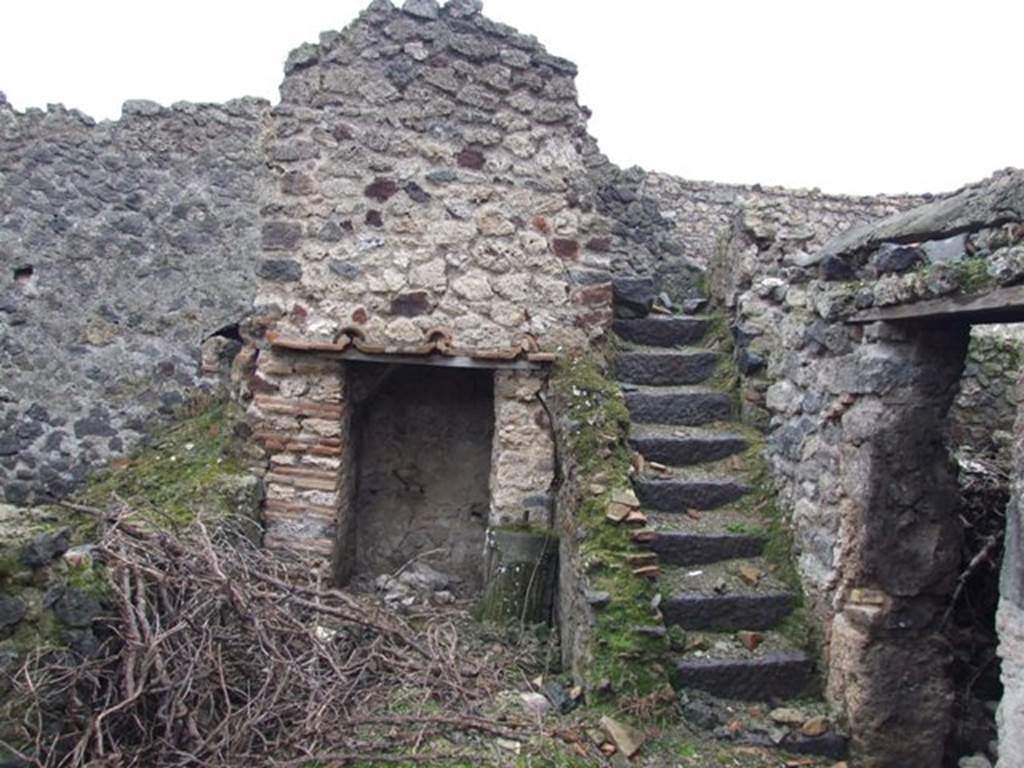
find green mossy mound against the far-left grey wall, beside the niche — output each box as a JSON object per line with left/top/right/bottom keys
{"left": 79, "top": 400, "right": 245, "bottom": 528}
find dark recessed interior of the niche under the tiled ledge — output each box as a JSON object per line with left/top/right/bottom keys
{"left": 349, "top": 364, "right": 495, "bottom": 597}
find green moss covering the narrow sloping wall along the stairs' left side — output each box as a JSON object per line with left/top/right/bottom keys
{"left": 553, "top": 355, "right": 668, "bottom": 699}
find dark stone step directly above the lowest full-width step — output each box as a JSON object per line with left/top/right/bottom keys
{"left": 660, "top": 592, "right": 796, "bottom": 632}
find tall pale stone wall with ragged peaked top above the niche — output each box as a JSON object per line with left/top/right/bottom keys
{"left": 251, "top": 0, "right": 610, "bottom": 350}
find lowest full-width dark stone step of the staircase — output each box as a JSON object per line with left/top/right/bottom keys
{"left": 672, "top": 650, "right": 814, "bottom": 701}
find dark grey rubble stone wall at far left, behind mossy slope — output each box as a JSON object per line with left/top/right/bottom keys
{"left": 0, "top": 95, "right": 268, "bottom": 503}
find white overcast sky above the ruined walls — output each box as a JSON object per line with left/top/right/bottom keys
{"left": 0, "top": 0, "right": 1024, "bottom": 194}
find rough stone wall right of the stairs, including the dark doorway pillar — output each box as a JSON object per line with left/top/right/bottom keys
{"left": 712, "top": 173, "right": 1024, "bottom": 765}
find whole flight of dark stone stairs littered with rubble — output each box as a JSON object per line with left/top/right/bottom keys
{"left": 613, "top": 284, "right": 845, "bottom": 754}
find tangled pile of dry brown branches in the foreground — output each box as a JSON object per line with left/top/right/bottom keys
{"left": 6, "top": 507, "right": 527, "bottom": 768}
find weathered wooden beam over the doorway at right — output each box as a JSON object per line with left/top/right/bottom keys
{"left": 847, "top": 286, "right": 1024, "bottom": 325}
